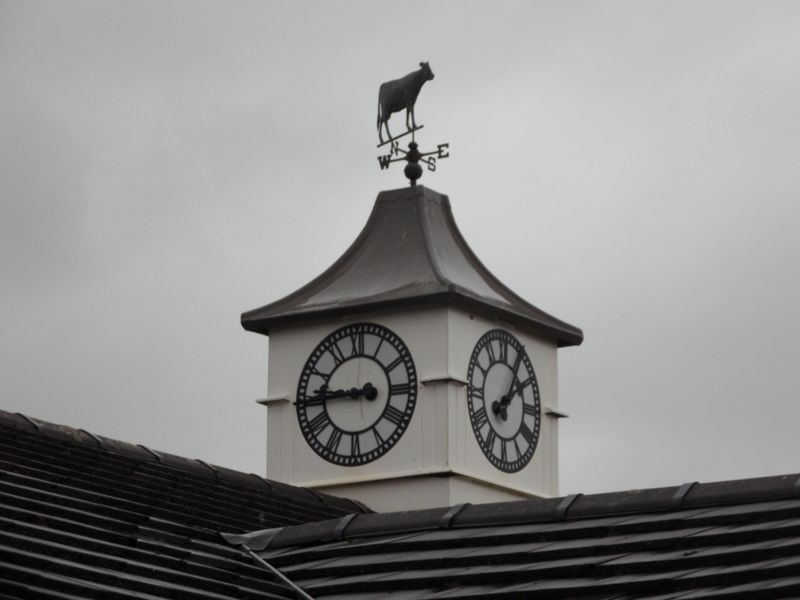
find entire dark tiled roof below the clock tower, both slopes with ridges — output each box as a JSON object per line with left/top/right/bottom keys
{"left": 0, "top": 411, "right": 800, "bottom": 600}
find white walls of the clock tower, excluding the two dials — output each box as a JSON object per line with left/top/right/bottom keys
{"left": 266, "top": 307, "right": 558, "bottom": 511}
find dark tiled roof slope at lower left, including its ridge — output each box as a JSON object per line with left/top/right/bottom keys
{"left": 0, "top": 411, "right": 365, "bottom": 600}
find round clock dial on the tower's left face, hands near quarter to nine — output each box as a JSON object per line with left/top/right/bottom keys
{"left": 296, "top": 323, "right": 417, "bottom": 466}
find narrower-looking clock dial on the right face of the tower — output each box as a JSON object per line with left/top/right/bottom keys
{"left": 467, "top": 329, "right": 541, "bottom": 473}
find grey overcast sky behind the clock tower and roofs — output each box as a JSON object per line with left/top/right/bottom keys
{"left": 0, "top": 0, "right": 800, "bottom": 493}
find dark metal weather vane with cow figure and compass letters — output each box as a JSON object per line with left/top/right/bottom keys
{"left": 378, "top": 62, "right": 450, "bottom": 185}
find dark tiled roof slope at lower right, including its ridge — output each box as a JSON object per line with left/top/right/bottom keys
{"left": 223, "top": 475, "right": 800, "bottom": 600}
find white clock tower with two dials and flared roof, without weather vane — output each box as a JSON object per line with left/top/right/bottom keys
{"left": 242, "top": 185, "right": 583, "bottom": 511}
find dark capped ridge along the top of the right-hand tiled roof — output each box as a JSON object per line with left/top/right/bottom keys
{"left": 231, "top": 473, "right": 800, "bottom": 549}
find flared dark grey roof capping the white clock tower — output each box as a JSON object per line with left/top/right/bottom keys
{"left": 242, "top": 186, "right": 583, "bottom": 346}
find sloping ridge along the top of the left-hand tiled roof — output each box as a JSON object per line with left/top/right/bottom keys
{"left": 0, "top": 410, "right": 369, "bottom": 513}
